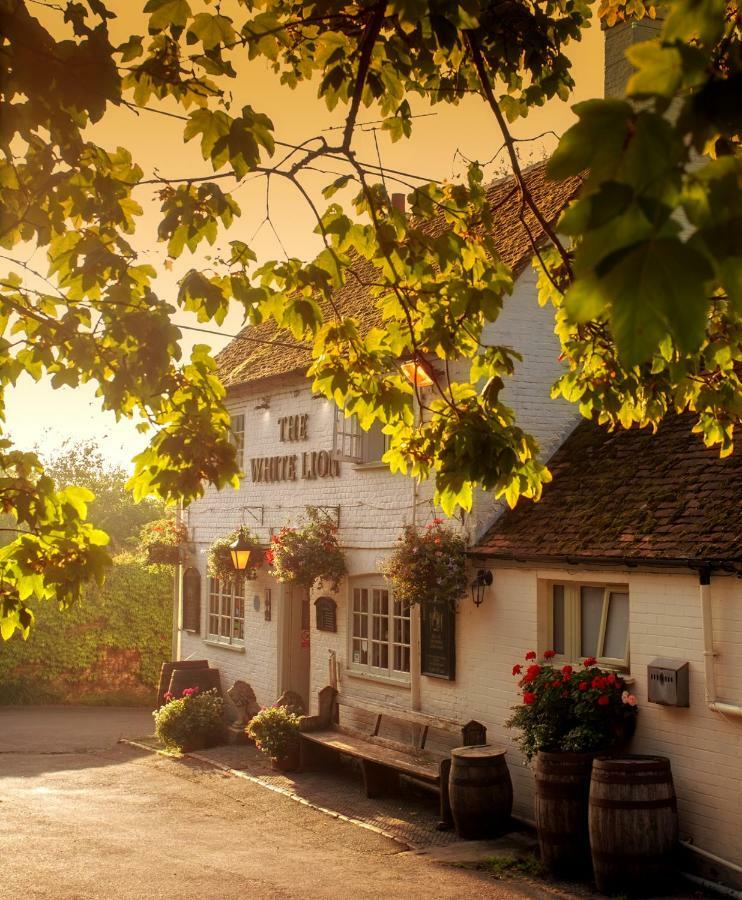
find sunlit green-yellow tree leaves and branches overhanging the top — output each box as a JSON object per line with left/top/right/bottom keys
{"left": 0, "top": 0, "right": 742, "bottom": 637}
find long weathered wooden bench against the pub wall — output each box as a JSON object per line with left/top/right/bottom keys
{"left": 300, "top": 686, "right": 487, "bottom": 828}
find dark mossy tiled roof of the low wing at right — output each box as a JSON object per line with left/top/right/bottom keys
{"left": 473, "top": 415, "right": 742, "bottom": 571}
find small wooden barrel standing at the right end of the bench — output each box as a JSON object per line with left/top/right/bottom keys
{"left": 448, "top": 744, "right": 513, "bottom": 840}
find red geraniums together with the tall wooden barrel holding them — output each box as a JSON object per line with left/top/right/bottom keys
{"left": 506, "top": 650, "right": 637, "bottom": 875}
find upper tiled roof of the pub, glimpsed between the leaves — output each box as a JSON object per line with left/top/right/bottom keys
{"left": 216, "top": 163, "right": 580, "bottom": 387}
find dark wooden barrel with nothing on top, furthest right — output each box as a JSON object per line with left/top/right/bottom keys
{"left": 590, "top": 756, "right": 678, "bottom": 895}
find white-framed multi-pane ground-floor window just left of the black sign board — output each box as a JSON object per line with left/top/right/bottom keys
{"left": 350, "top": 582, "right": 410, "bottom": 678}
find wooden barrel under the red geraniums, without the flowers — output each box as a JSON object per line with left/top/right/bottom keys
{"left": 535, "top": 752, "right": 594, "bottom": 875}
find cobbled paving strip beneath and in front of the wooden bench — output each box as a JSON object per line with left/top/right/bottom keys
{"left": 198, "top": 744, "right": 459, "bottom": 849}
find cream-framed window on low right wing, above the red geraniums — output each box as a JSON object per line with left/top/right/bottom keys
{"left": 548, "top": 582, "right": 629, "bottom": 669}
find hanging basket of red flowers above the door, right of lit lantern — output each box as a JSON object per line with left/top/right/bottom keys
{"left": 270, "top": 508, "right": 347, "bottom": 591}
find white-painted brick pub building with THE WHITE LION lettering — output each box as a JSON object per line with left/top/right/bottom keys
{"left": 178, "top": 26, "right": 742, "bottom": 886}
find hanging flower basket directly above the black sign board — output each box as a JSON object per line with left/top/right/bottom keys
{"left": 381, "top": 519, "right": 467, "bottom": 609}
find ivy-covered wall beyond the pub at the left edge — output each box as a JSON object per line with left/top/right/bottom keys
{"left": 0, "top": 554, "right": 173, "bottom": 704}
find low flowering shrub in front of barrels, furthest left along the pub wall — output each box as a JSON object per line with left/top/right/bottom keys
{"left": 152, "top": 688, "right": 224, "bottom": 753}
